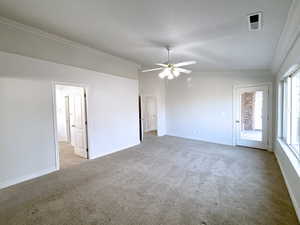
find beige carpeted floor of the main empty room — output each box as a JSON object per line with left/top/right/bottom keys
{"left": 0, "top": 136, "right": 298, "bottom": 225}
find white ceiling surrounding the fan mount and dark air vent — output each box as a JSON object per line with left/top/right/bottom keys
{"left": 0, "top": 0, "right": 292, "bottom": 71}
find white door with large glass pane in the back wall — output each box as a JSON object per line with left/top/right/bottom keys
{"left": 235, "top": 86, "right": 269, "bottom": 149}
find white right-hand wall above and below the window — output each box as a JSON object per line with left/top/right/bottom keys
{"left": 273, "top": 0, "right": 300, "bottom": 221}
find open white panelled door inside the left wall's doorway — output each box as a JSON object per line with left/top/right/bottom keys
{"left": 69, "top": 88, "right": 87, "bottom": 158}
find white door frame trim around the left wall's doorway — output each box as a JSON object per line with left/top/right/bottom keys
{"left": 52, "top": 81, "right": 91, "bottom": 170}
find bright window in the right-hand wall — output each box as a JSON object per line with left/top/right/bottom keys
{"left": 281, "top": 70, "right": 300, "bottom": 160}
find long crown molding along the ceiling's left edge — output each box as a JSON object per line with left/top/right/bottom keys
{"left": 0, "top": 16, "right": 140, "bottom": 68}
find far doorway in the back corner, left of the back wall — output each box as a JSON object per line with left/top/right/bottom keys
{"left": 142, "top": 96, "right": 157, "bottom": 136}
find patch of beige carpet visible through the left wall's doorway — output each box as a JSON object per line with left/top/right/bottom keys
{"left": 59, "top": 142, "right": 86, "bottom": 169}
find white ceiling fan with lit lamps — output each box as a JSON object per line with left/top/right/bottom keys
{"left": 142, "top": 47, "right": 196, "bottom": 80}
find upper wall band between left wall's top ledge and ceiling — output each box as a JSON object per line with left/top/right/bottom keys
{"left": 0, "top": 17, "right": 138, "bottom": 79}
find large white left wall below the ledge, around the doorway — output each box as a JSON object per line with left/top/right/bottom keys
{"left": 0, "top": 52, "right": 139, "bottom": 188}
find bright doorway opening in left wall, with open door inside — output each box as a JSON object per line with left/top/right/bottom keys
{"left": 55, "top": 85, "right": 89, "bottom": 168}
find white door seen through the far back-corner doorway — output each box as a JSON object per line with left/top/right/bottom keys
{"left": 144, "top": 96, "right": 157, "bottom": 132}
